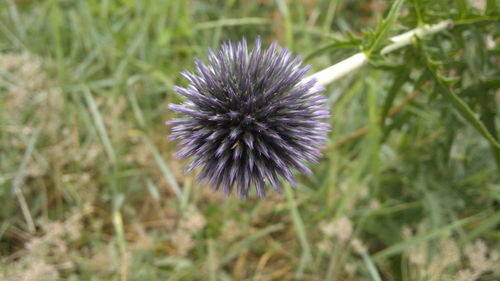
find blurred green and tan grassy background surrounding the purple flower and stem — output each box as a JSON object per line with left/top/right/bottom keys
{"left": 0, "top": 0, "right": 500, "bottom": 281}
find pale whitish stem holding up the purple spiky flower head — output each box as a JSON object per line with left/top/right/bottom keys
{"left": 308, "top": 20, "right": 453, "bottom": 86}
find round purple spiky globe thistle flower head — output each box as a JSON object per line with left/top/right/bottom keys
{"left": 167, "top": 38, "right": 329, "bottom": 198}
